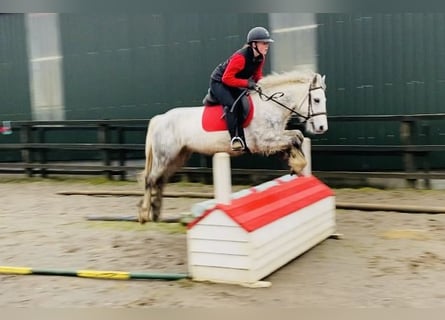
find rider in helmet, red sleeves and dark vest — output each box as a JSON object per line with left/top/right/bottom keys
{"left": 210, "top": 27, "right": 273, "bottom": 151}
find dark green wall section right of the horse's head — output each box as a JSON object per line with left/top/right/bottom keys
{"left": 313, "top": 13, "right": 445, "bottom": 170}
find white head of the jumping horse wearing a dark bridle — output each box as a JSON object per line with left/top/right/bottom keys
{"left": 304, "top": 73, "right": 328, "bottom": 134}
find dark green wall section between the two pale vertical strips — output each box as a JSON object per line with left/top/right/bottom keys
{"left": 60, "top": 14, "right": 267, "bottom": 119}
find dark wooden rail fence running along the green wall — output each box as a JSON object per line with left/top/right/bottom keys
{"left": 0, "top": 113, "right": 445, "bottom": 183}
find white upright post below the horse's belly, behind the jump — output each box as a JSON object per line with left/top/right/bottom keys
{"left": 212, "top": 152, "right": 232, "bottom": 204}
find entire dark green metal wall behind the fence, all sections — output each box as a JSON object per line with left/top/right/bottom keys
{"left": 0, "top": 13, "right": 445, "bottom": 170}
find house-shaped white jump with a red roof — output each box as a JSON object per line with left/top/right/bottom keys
{"left": 187, "top": 151, "right": 336, "bottom": 286}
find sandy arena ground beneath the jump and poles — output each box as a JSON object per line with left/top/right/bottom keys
{"left": 0, "top": 178, "right": 445, "bottom": 308}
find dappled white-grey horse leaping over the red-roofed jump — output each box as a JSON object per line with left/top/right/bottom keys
{"left": 138, "top": 71, "right": 328, "bottom": 223}
